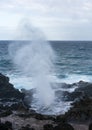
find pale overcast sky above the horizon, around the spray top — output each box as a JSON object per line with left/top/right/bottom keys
{"left": 0, "top": 0, "right": 92, "bottom": 40}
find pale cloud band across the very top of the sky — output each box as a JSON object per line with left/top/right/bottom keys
{"left": 0, "top": 0, "right": 92, "bottom": 19}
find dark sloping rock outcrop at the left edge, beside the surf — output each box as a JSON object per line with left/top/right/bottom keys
{"left": 0, "top": 73, "right": 25, "bottom": 117}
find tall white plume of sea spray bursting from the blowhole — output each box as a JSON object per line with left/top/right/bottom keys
{"left": 9, "top": 23, "right": 54, "bottom": 106}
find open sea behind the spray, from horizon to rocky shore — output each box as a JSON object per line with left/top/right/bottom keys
{"left": 0, "top": 41, "right": 92, "bottom": 89}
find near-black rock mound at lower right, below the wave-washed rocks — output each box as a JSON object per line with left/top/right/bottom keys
{"left": 64, "top": 96, "right": 92, "bottom": 122}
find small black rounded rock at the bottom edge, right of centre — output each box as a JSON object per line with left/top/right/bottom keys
{"left": 53, "top": 123, "right": 74, "bottom": 130}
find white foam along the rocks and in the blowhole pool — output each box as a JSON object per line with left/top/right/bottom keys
{"left": 7, "top": 71, "right": 92, "bottom": 115}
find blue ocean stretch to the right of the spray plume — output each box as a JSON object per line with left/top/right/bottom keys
{"left": 53, "top": 41, "right": 92, "bottom": 83}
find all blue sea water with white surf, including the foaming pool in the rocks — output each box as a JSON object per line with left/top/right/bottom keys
{"left": 0, "top": 41, "right": 92, "bottom": 114}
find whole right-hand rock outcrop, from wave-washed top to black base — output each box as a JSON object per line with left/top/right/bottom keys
{"left": 55, "top": 81, "right": 92, "bottom": 122}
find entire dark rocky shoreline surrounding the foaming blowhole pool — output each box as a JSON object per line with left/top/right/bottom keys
{"left": 0, "top": 74, "right": 92, "bottom": 130}
